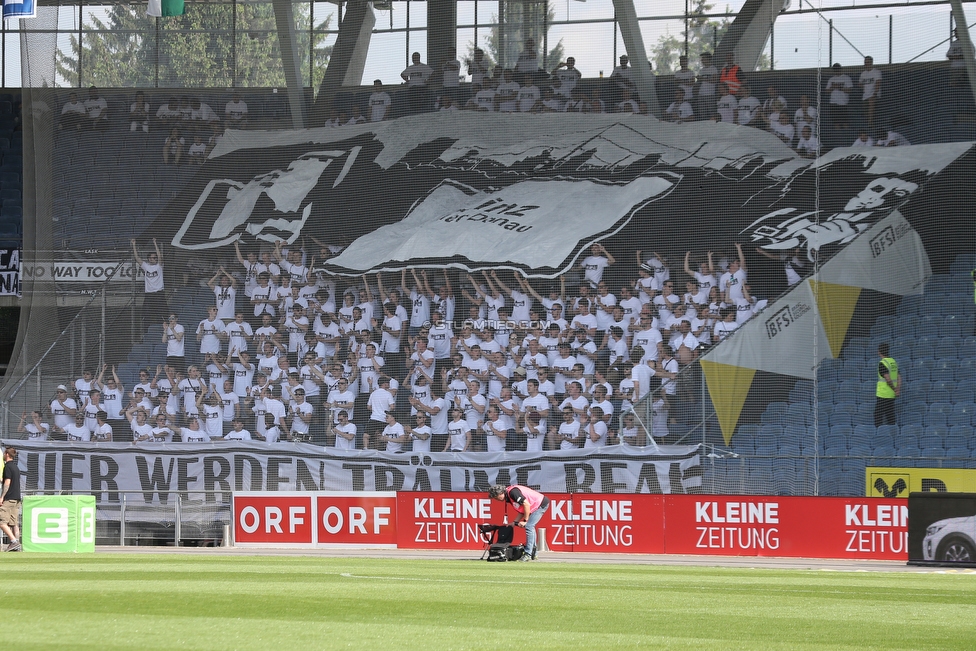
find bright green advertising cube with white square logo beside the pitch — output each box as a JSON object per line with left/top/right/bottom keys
{"left": 21, "top": 495, "right": 95, "bottom": 554}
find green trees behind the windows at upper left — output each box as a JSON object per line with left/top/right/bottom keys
{"left": 57, "top": 3, "right": 333, "bottom": 88}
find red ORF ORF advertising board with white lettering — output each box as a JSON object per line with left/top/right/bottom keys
{"left": 233, "top": 492, "right": 396, "bottom": 547}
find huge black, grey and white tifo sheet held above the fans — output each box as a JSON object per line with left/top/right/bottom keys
{"left": 156, "top": 112, "right": 972, "bottom": 277}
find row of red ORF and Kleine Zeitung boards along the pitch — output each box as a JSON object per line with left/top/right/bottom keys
{"left": 233, "top": 492, "right": 908, "bottom": 560}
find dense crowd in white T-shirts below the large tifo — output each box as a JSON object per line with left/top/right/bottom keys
{"left": 19, "top": 240, "right": 790, "bottom": 452}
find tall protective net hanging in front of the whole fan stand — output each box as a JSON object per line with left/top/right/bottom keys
{"left": 0, "top": 2, "right": 976, "bottom": 508}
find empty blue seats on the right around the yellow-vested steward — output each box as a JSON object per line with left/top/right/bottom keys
{"left": 732, "top": 255, "right": 976, "bottom": 495}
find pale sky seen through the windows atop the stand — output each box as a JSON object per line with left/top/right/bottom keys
{"left": 2, "top": 0, "right": 964, "bottom": 87}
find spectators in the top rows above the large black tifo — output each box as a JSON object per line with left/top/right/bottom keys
{"left": 51, "top": 39, "right": 932, "bottom": 165}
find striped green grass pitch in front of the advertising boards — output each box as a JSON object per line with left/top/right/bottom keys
{"left": 0, "top": 554, "right": 976, "bottom": 651}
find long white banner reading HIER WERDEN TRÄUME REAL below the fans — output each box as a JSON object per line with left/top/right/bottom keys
{"left": 9, "top": 441, "right": 701, "bottom": 501}
